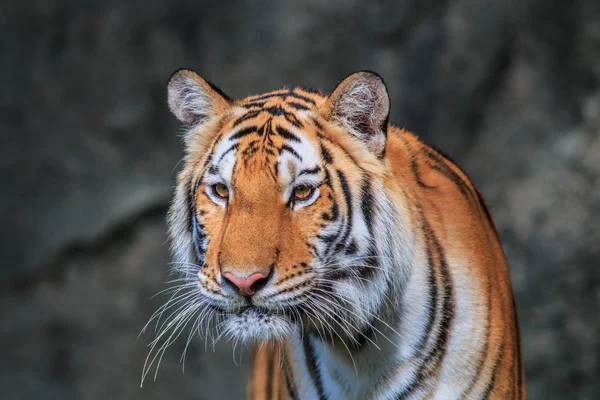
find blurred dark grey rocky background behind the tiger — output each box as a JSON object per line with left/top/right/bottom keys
{"left": 0, "top": 0, "right": 600, "bottom": 400}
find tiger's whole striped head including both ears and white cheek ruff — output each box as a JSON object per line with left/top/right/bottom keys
{"left": 168, "top": 69, "right": 410, "bottom": 341}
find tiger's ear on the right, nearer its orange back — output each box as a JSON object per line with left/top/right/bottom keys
{"left": 320, "top": 71, "right": 390, "bottom": 158}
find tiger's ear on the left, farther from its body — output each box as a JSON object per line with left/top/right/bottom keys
{"left": 167, "top": 69, "right": 233, "bottom": 127}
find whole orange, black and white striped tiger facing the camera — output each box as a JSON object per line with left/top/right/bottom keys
{"left": 159, "top": 69, "right": 526, "bottom": 400}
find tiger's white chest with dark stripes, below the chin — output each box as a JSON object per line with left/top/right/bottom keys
{"left": 285, "top": 324, "right": 417, "bottom": 400}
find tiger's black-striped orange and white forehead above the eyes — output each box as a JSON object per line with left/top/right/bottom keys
{"left": 205, "top": 96, "right": 320, "bottom": 190}
